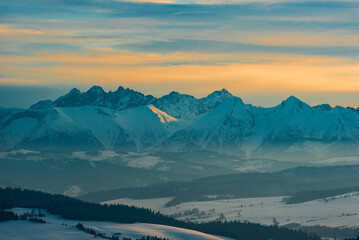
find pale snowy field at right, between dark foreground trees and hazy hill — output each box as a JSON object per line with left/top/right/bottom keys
{"left": 104, "top": 192, "right": 359, "bottom": 227}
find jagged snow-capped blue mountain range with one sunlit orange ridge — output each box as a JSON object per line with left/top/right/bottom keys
{"left": 0, "top": 86, "right": 359, "bottom": 160}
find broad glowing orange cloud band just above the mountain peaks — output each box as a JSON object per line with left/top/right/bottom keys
{"left": 0, "top": 49, "right": 359, "bottom": 95}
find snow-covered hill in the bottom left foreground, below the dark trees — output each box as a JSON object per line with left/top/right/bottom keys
{"left": 0, "top": 208, "right": 230, "bottom": 240}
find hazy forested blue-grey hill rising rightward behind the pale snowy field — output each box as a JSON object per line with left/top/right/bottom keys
{"left": 80, "top": 165, "right": 359, "bottom": 205}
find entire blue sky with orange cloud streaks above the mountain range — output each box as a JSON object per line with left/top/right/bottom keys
{"left": 0, "top": 0, "right": 359, "bottom": 107}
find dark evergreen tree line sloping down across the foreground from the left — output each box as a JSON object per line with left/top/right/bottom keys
{"left": 0, "top": 188, "right": 320, "bottom": 240}
